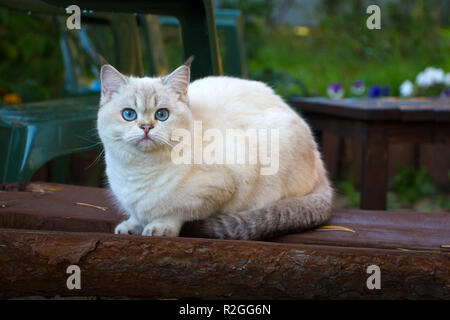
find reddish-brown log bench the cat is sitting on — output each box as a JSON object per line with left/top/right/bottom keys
{"left": 0, "top": 182, "right": 450, "bottom": 299}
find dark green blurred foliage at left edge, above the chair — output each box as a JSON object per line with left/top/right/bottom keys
{"left": 0, "top": 8, "right": 64, "bottom": 101}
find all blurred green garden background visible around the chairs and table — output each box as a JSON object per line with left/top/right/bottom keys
{"left": 0, "top": 0, "right": 450, "bottom": 211}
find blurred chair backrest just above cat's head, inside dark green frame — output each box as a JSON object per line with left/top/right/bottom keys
{"left": 58, "top": 14, "right": 144, "bottom": 95}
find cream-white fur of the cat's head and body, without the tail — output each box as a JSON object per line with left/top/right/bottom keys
{"left": 98, "top": 63, "right": 328, "bottom": 236}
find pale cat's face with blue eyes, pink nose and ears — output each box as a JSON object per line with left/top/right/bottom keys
{"left": 97, "top": 64, "right": 193, "bottom": 153}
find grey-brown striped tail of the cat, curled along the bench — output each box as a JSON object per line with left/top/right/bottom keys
{"left": 180, "top": 182, "right": 333, "bottom": 240}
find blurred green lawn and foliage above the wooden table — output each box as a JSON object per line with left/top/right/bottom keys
{"left": 222, "top": 0, "right": 450, "bottom": 96}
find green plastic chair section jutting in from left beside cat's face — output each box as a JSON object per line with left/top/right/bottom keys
{"left": 0, "top": 95, "right": 98, "bottom": 183}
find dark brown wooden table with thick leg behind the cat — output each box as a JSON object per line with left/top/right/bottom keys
{"left": 290, "top": 98, "right": 450, "bottom": 210}
